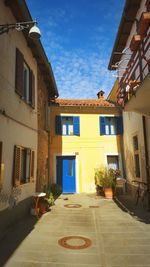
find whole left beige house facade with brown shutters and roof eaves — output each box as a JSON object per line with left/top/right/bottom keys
{"left": 0, "top": 0, "right": 58, "bottom": 235}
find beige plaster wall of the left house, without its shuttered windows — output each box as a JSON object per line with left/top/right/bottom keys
{"left": 0, "top": 1, "right": 37, "bottom": 211}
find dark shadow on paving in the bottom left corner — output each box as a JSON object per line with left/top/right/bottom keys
{"left": 0, "top": 216, "right": 37, "bottom": 266}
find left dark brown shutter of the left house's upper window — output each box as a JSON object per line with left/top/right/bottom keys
{"left": 15, "top": 48, "right": 24, "bottom": 97}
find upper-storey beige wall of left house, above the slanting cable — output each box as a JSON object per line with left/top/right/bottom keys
{"left": 0, "top": 1, "right": 37, "bottom": 129}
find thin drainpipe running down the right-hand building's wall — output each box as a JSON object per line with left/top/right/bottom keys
{"left": 142, "top": 116, "right": 150, "bottom": 210}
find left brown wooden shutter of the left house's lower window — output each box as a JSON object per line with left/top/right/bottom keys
{"left": 13, "top": 146, "right": 21, "bottom": 186}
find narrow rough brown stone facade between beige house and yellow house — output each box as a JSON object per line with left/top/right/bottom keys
{"left": 36, "top": 60, "right": 58, "bottom": 192}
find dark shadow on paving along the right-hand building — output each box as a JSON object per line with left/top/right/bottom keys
{"left": 114, "top": 194, "right": 150, "bottom": 224}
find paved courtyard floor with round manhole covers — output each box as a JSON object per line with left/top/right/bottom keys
{"left": 0, "top": 194, "right": 150, "bottom": 267}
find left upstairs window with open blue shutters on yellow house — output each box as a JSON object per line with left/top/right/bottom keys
{"left": 55, "top": 116, "right": 80, "bottom": 135}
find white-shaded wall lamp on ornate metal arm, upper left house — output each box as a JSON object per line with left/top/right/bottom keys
{"left": 0, "top": 20, "right": 41, "bottom": 39}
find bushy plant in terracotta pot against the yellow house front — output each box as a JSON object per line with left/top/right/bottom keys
{"left": 95, "top": 167, "right": 116, "bottom": 198}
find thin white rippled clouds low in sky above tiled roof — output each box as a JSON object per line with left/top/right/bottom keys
{"left": 49, "top": 51, "right": 113, "bottom": 98}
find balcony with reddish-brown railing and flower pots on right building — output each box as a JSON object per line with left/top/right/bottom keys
{"left": 117, "top": 31, "right": 150, "bottom": 108}
